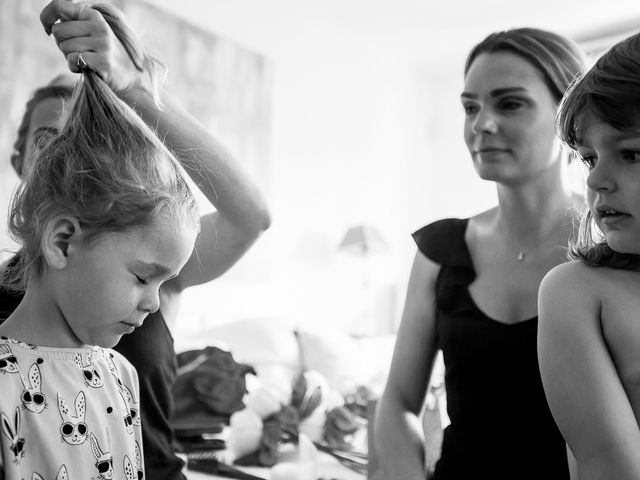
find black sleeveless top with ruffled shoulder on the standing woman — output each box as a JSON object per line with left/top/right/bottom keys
{"left": 413, "top": 219, "right": 569, "bottom": 480}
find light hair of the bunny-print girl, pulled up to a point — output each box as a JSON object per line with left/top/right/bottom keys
{"left": 2, "top": 71, "right": 199, "bottom": 290}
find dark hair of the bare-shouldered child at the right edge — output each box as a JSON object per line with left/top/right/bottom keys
{"left": 557, "top": 34, "right": 640, "bottom": 268}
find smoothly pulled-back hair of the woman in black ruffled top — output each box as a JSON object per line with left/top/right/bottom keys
{"left": 464, "top": 28, "right": 586, "bottom": 102}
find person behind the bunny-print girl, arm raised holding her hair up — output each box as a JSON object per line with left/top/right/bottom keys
{"left": 0, "top": 1, "right": 270, "bottom": 480}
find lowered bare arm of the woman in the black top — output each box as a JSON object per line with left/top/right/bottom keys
{"left": 375, "top": 252, "right": 440, "bottom": 480}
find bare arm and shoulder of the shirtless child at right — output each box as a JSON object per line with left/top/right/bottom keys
{"left": 538, "top": 262, "right": 640, "bottom": 480}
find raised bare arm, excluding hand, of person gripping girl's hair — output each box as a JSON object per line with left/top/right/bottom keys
{"left": 123, "top": 89, "right": 271, "bottom": 291}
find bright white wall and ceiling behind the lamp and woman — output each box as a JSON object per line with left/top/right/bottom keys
{"left": 122, "top": 0, "right": 640, "bottom": 336}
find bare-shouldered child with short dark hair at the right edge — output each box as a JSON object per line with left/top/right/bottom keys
{"left": 538, "top": 35, "right": 640, "bottom": 480}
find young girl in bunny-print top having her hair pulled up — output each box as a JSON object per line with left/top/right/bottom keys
{"left": 0, "top": 39, "right": 199, "bottom": 480}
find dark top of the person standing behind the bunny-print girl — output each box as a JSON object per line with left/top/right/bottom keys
{"left": 0, "top": 260, "right": 185, "bottom": 480}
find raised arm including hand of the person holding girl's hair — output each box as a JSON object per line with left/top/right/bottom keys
{"left": 41, "top": 0, "right": 271, "bottom": 292}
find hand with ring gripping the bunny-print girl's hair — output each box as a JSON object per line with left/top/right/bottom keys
{"left": 40, "top": 0, "right": 150, "bottom": 94}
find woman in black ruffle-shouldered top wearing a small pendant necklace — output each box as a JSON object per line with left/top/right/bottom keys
{"left": 375, "top": 28, "right": 584, "bottom": 480}
